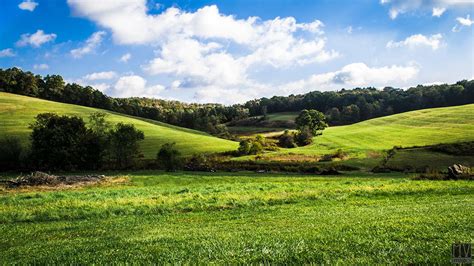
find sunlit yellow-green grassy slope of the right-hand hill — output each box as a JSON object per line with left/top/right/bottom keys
{"left": 287, "top": 104, "right": 474, "bottom": 157}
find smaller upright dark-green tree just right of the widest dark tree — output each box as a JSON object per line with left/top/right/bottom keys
{"left": 109, "top": 123, "right": 145, "bottom": 168}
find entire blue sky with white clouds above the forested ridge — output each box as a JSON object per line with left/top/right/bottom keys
{"left": 0, "top": 0, "right": 474, "bottom": 104}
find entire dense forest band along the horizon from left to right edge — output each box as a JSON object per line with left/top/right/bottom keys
{"left": 0, "top": 68, "right": 474, "bottom": 132}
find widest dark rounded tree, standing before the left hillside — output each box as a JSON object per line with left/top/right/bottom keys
{"left": 30, "top": 113, "right": 102, "bottom": 170}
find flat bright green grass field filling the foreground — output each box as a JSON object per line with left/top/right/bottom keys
{"left": 0, "top": 172, "right": 474, "bottom": 264}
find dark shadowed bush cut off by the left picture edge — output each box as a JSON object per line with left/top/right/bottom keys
{"left": 0, "top": 137, "right": 24, "bottom": 169}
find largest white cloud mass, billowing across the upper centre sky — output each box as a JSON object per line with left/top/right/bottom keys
{"left": 68, "top": 0, "right": 339, "bottom": 102}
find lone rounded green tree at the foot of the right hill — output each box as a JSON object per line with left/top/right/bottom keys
{"left": 295, "top": 109, "right": 328, "bottom": 146}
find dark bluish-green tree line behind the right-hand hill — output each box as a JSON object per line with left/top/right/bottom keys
{"left": 243, "top": 80, "right": 474, "bottom": 125}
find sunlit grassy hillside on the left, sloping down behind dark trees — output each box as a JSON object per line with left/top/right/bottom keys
{"left": 0, "top": 92, "right": 238, "bottom": 158}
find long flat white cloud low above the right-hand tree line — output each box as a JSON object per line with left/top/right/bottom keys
{"left": 280, "top": 63, "right": 419, "bottom": 94}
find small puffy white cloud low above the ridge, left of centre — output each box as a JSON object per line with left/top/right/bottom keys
{"left": 112, "top": 75, "right": 165, "bottom": 97}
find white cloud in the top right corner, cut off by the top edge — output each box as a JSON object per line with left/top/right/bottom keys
{"left": 380, "top": 0, "right": 474, "bottom": 19}
